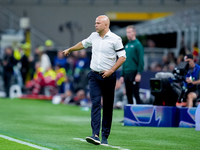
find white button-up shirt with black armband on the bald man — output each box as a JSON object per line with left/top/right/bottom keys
{"left": 82, "top": 30, "right": 126, "bottom": 72}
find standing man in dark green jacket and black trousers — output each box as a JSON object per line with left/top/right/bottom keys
{"left": 121, "top": 25, "right": 144, "bottom": 104}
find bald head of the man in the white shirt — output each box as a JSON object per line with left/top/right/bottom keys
{"left": 95, "top": 15, "right": 110, "bottom": 36}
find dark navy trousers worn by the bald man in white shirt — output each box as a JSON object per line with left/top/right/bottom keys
{"left": 88, "top": 71, "right": 116, "bottom": 138}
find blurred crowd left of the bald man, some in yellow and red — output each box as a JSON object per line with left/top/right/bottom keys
{"left": 1, "top": 40, "right": 90, "bottom": 103}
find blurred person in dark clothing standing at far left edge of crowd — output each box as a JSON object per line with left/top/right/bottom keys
{"left": 2, "top": 47, "right": 17, "bottom": 97}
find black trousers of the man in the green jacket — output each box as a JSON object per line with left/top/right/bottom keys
{"left": 124, "top": 71, "right": 141, "bottom": 104}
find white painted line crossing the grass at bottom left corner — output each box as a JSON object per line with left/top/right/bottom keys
{"left": 0, "top": 134, "right": 52, "bottom": 150}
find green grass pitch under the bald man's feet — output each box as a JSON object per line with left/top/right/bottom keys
{"left": 0, "top": 98, "right": 200, "bottom": 150}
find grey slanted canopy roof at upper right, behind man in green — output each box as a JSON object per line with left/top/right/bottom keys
{"left": 117, "top": 6, "right": 200, "bottom": 56}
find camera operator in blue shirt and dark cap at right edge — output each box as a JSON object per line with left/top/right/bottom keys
{"left": 184, "top": 54, "right": 200, "bottom": 107}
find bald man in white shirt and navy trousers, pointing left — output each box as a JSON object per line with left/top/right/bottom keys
{"left": 63, "top": 15, "right": 126, "bottom": 145}
